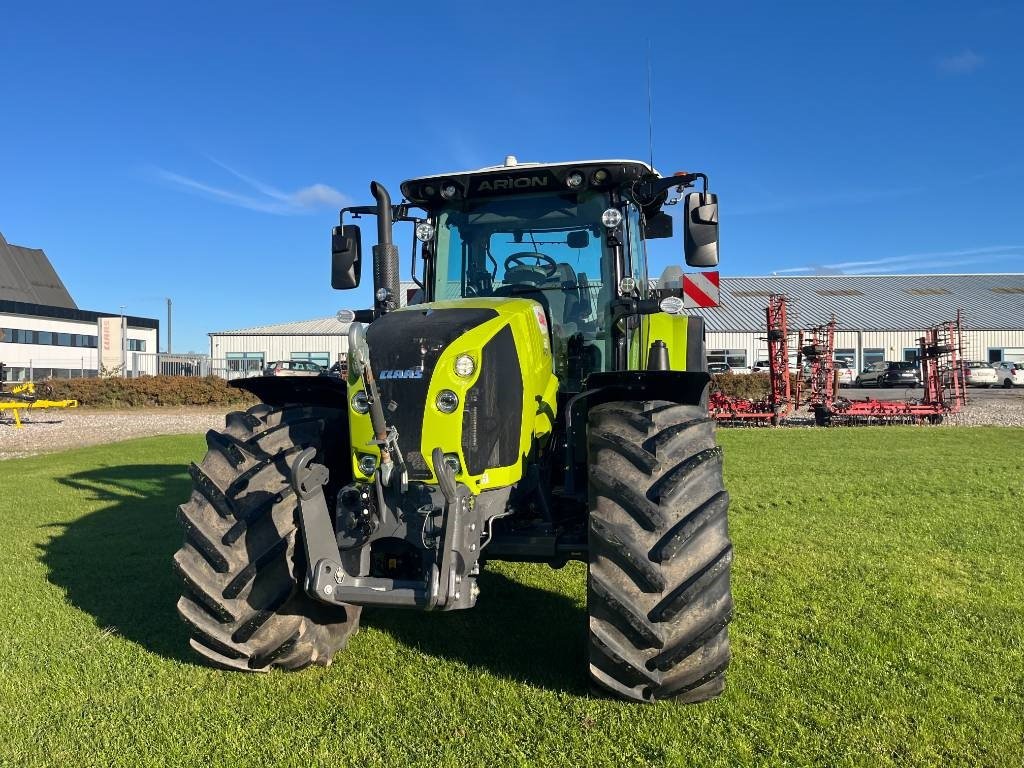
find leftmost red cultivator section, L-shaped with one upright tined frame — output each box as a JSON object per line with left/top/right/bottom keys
{"left": 709, "top": 294, "right": 794, "bottom": 426}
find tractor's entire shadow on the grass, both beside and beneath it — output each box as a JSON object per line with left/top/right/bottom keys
{"left": 40, "top": 464, "right": 588, "bottom": 693}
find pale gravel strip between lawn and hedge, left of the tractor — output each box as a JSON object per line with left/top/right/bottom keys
{"left": 0, "top": 409, "right": 225, "bottom": 460}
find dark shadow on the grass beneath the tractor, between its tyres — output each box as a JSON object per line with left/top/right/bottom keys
{"left": 362, "top": 565, "right": 589, "bottom": 694}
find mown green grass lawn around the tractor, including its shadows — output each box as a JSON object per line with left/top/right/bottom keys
{"left": 0, "top": 427, "right": 1024, "bottom": 768}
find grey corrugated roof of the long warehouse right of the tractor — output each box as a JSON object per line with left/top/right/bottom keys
{"left": 687, "top": 273, "right": 1024, "bottom": 331}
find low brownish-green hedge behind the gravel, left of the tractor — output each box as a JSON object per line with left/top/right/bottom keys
{"left": 36, "top": 376, "right": 257, "bottom": 408}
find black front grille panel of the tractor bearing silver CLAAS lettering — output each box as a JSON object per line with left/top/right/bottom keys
{"left": 367, "top": 307, "right": 498, "bottom": 480}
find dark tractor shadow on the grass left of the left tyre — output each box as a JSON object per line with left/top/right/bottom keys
{"left": 40, "top": 464, "right": 197, "bottom": 663}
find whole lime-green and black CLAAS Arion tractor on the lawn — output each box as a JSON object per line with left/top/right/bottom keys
{"left": 174, "top": 157, "right": 732, "bottom": 702}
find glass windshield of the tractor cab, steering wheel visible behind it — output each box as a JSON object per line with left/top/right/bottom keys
{"left": 434, "top": 193, "right": 613, "bottom": 378}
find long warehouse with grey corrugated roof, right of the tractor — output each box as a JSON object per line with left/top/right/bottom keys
{"left": 692, "top": 273, "right": 1024, "bottom": 369}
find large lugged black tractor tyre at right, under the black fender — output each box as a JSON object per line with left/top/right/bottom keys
{"left": 587, "top": 401, "right": 732, "bottom": 702}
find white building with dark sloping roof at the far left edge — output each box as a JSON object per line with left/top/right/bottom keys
{"left": 0, "top": 234, "right": 160, "bottom": 381}
